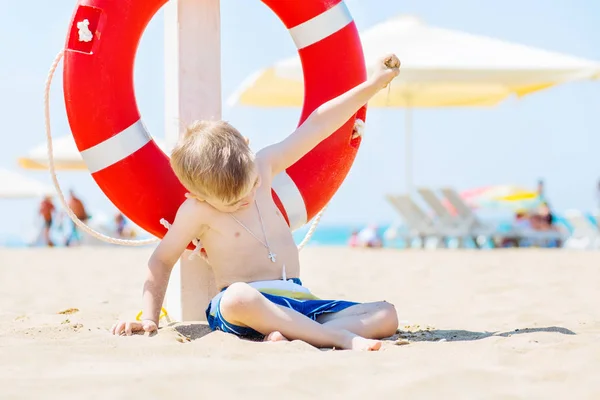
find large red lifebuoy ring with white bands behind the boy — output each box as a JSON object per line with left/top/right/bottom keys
{"left": 63, "top": 0, "right": 366, "bottom": 248}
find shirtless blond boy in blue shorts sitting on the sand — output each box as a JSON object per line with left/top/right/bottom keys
{"left": 111, "top": 55, "right": 400, "bottom": 350}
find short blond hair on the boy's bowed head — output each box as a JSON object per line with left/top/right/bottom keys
{"left": 171, "top": 121, "right": 256, "bottom": 202}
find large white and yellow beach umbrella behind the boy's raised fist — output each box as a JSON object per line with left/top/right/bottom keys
{"left": 228, "top": 16, "right": 600, "bottom": 189}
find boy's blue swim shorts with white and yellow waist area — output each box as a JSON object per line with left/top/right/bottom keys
{"left": 206, "top": 278, "right": 359, "bottom": 338}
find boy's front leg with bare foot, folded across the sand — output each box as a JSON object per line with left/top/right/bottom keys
{"left": 220, "top": 283, "right": 381, "bottom": 350}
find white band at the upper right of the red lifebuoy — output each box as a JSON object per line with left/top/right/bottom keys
{"left": 289, "top": 1, "right": 352, "bottom": 50}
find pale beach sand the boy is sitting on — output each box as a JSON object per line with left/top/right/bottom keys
{"left": 0, "top": 247, "right": 600, "bottom": 400}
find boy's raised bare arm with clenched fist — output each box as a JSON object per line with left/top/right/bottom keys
{"left": 258, "top": 55, "right": 400, "bottom": 176}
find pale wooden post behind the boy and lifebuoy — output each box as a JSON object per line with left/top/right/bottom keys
{"left": 164, "top": 0, "right": 221, "bottom": 321}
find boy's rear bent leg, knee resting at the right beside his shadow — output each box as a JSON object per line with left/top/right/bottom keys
{"left": 317, "top": 301, "right": 398, "bottom": 339}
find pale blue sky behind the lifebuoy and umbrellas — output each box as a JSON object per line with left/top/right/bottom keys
{"left": 0, "top": 0, "right": 600, "bottom": 235}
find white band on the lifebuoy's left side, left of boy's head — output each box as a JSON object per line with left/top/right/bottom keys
{"left": 81, "top": 119, "right": 152, "bottom": 173}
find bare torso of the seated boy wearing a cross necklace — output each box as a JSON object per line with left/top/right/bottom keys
{"left": 187, "top": 158, "right": 300, "bottom": 289}
